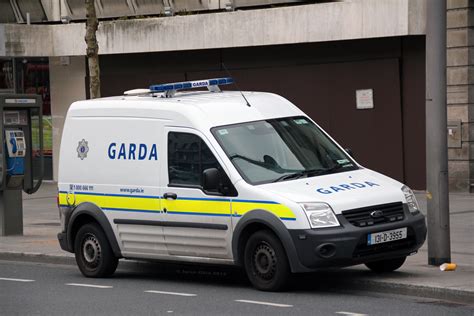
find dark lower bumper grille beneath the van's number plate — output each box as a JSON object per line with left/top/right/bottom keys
{"left": 353, "top": 227, "right": 416, "bottom": 258}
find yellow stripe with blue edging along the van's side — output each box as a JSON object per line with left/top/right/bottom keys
{"left": 59, "top": 191, "right": 296, "bottom": 221}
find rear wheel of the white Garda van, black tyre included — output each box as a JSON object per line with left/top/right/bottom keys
{"left": 74, "top": 223, "right": 118, "bottom": 278}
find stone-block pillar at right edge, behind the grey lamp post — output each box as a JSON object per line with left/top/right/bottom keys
{"left": 447, "top": 0, "right": 474, "bottom": 192}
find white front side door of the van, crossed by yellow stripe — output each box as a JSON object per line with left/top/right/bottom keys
{"left": 160, "top": 127, "right": 232, "bottom": 259}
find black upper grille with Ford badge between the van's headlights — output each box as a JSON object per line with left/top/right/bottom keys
{"left": 342, "top": 202, "right": 405, "bottom": 227}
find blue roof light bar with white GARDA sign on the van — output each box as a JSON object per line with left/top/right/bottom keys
{"left": 150, "top": 77, "right": 234, "bottom": 98}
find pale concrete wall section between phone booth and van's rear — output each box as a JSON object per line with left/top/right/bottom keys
{"left": 49, "top": 56, "right": 86, "bottom": 181}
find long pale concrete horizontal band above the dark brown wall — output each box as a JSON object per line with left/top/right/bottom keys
{"left": 0, "top": 0, "right": 426, "bottom": 57}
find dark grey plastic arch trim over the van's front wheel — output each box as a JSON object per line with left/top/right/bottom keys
{"left": 232, "top": 210, "right": 312, "bottom": 272}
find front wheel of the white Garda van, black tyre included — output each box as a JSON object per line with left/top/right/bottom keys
{"left": 244, "top": 230, "right": 290, "bottom": 291}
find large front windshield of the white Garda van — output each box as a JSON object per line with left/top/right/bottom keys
{"left": 211, "top": 116, "right": 358, "bottom": 184}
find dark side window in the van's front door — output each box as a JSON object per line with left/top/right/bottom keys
{"left": 168, "top": 132, "right": 222, "bottom": 186}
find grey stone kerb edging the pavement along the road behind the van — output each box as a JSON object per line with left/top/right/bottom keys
{"left": 0, "top": 252, "right": 474, "bottom": 305}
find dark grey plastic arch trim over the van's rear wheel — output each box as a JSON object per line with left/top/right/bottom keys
{"left": 67, "top": 202, "right": 122, "bottom": 258}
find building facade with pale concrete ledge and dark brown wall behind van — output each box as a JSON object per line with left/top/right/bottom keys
{"left": 0, "top": 0, "right": 474, "bottom": 191}
